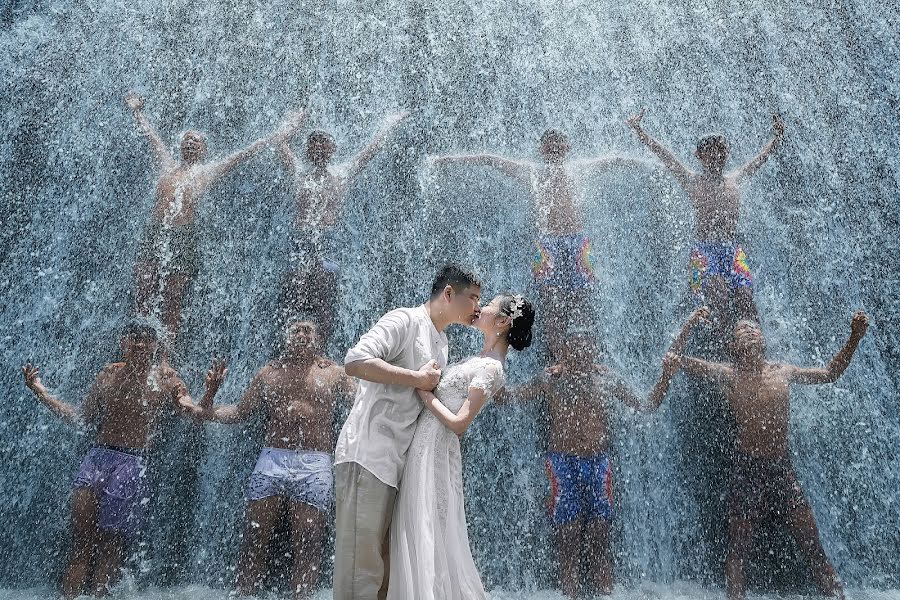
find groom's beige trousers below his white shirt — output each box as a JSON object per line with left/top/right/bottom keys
{"left": 334, "top": 463, "right": 397, "bottom": 600}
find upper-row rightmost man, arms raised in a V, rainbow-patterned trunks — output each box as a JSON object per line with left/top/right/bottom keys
{"left": 627, "top": 110, "right": 784, "bottom": 340}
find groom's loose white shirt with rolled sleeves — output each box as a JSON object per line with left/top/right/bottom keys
{"left": 334, "top": 306, "right": 448, "bottom": 488}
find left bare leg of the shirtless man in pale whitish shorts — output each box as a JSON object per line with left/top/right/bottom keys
{"left": 237, "top": 496, "right": 284, "bottom": 596}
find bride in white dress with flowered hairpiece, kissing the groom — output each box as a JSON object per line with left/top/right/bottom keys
{"left": 387, "top": 294, "right": 534, "bottom": 600}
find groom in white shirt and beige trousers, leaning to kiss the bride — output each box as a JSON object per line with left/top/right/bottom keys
{"left": 334, "top": 265, "right": 481, "bottom": 600}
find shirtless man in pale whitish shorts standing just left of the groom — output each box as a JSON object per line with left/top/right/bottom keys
{"left": 183, "top": 321, "right": 356, "bottom": 599}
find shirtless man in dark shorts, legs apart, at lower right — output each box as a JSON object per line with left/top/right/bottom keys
{"left": 675, "top": 311, "right": 869, "bottom": 600}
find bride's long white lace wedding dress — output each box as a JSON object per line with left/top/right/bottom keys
{"left": 387, "top": 356, "right": 504, "bottom": 600}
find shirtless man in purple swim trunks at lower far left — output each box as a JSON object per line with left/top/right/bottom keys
{"left": 22, "top": 322, "right": 224, "bottom": 598}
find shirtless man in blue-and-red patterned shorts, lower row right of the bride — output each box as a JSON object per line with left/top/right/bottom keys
{"left": 496, "top": 322, "right": 705, "bottom": 598}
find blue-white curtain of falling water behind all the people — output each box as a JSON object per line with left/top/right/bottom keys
{"left": 0, "top": 0, "right": 900, "bottom": 589}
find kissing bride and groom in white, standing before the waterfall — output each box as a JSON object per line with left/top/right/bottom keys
{"left": 334, "top": 265, "right": 534, "bottom": 600}
